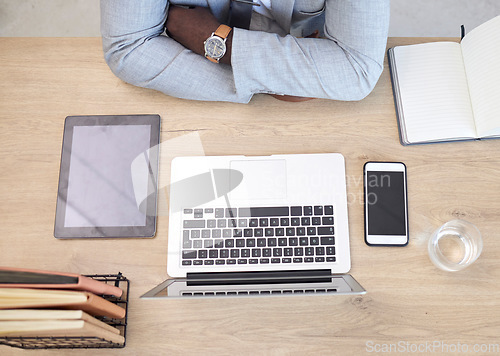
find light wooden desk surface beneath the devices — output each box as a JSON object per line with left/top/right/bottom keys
{"left": 0, "top": 38, "right": 500, "bottom": 355}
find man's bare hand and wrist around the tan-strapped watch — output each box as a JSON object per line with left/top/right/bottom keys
{"left": 166, "top": 6, "right": 233, "bottom": 64}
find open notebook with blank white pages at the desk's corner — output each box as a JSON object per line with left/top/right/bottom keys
{"left": 388, "top": 16, "right": 500, "bottom": 145}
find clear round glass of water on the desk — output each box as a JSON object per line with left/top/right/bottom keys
{"left": 427, "top": 220, "right": 483, "bottom": 272}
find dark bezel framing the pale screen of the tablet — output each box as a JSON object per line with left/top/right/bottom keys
{"left": 54, "top": 114, "right": 160, "bottom": 239}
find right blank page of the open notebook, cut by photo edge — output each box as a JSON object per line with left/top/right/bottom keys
{"left": 462, "top": 16, "right": 500, "bottom": 136}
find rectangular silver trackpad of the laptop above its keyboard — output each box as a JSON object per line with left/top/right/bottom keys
{"left": 230, "top": 159, "right": 287, "bottom": 200}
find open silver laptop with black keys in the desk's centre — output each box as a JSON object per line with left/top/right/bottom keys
{"left": 143, "top": 153, "right": 365, "bottom": 298}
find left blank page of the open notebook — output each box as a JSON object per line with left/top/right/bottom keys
{"left": 394, "top": 42, "right": 476, "bottom": 142}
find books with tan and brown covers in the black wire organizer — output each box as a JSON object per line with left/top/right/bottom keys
{"left": 0, "top": 267, "right": 126, "bottom": 345}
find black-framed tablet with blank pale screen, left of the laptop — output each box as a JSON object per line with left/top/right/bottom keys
{"left": 54, "top": 115, "right": 160, "bottom": 239}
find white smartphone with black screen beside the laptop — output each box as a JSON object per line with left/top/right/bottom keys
{"left": 363, "top": 162, "right": 409, "bottom": 246}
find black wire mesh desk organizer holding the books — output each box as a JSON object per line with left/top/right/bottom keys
{"left": 0, "top": 273, "right": 130, "bottom": 350}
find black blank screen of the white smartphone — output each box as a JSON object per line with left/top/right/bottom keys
{"left": 365, "top": 171, "right": 407, "bottom": 236}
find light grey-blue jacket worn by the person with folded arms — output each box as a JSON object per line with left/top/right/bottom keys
{"left": 101, "top": 0, "right": 390, "bottom": 103}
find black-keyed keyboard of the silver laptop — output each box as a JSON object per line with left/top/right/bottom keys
{"left": 182, "top": 205, "right": 336, "bottom": 266}
